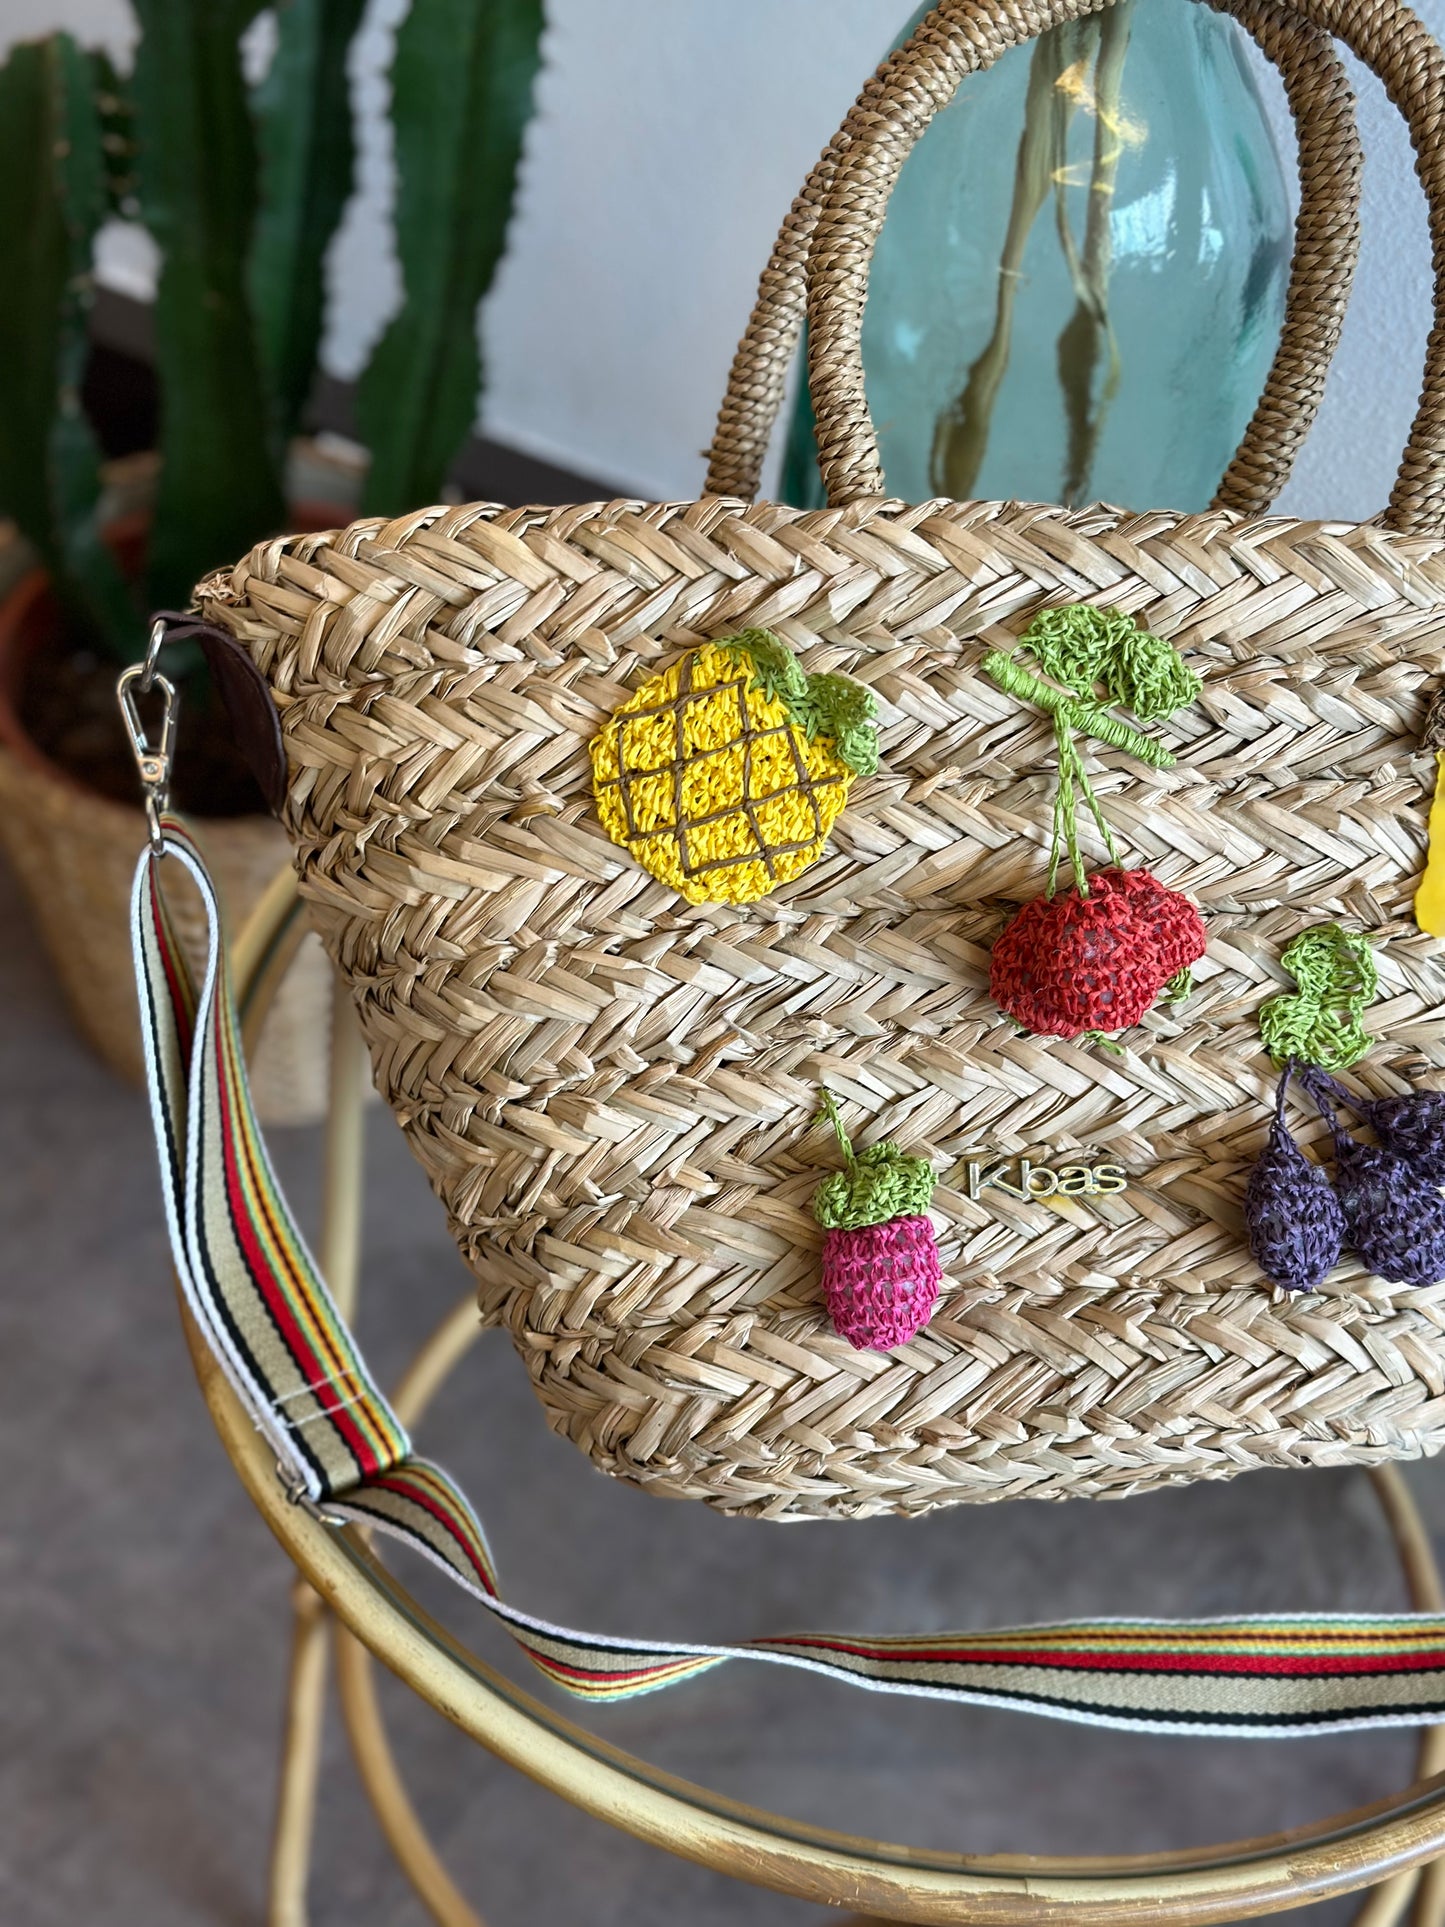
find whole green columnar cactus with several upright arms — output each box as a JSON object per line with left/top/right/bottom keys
{"left": 0, "top": 0, "right": 541, "bottom": 689}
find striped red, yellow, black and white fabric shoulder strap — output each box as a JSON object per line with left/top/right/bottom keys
{"left": 133, "top": 817, "right": 1445, "bottom": 1734}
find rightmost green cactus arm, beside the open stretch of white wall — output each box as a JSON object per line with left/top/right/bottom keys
{"left": 356, "top": 0, "right": 543, "bottom": 515}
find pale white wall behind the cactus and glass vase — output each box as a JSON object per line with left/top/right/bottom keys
{"left": 0, "top": 0, "right": 1445, "bottom": 516}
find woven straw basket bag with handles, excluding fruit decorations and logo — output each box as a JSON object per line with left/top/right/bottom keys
{"left": 198, "top": 0, "right": 1445, "bottom": 1517}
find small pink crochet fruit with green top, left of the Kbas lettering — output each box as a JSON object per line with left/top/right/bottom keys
{"left": 813, "top": 1091, "right": 942, "bottom": 1351}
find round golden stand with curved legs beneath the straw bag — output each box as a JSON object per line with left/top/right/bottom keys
{"left": 204, "top": 871, "right": 1445, "bottom": 1927}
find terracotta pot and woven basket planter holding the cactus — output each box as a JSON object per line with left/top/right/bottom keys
{"left": 0, "top": 511, "right": 335, "bottom": 1123}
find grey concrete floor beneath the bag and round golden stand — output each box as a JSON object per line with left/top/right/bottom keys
{"left": 0, "top": 859, "right": 1445, "bottom": 1927}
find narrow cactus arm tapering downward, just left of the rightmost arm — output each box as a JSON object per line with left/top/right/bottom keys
{"left": 247, "top": 0, "right": 366, "bottom": 451}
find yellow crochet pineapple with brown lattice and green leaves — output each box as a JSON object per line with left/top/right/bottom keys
{"left": 591, "top": 628, "right": 879, "bottom": 904}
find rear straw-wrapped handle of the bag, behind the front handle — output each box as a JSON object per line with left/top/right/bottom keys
{"left": 705, "top": 0, "right": 1362, "bottom": 515}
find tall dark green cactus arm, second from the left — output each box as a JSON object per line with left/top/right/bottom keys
{"left": 133, "top": 0, "right": 285, "bottom": 607}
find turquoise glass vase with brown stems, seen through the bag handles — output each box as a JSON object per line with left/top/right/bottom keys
{"left": 780, "top": 0, "right": 1291, "bottom": 509}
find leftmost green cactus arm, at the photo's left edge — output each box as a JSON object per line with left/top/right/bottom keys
{"left": 0, "top": 33, "right": 141, "bottom": 655}
